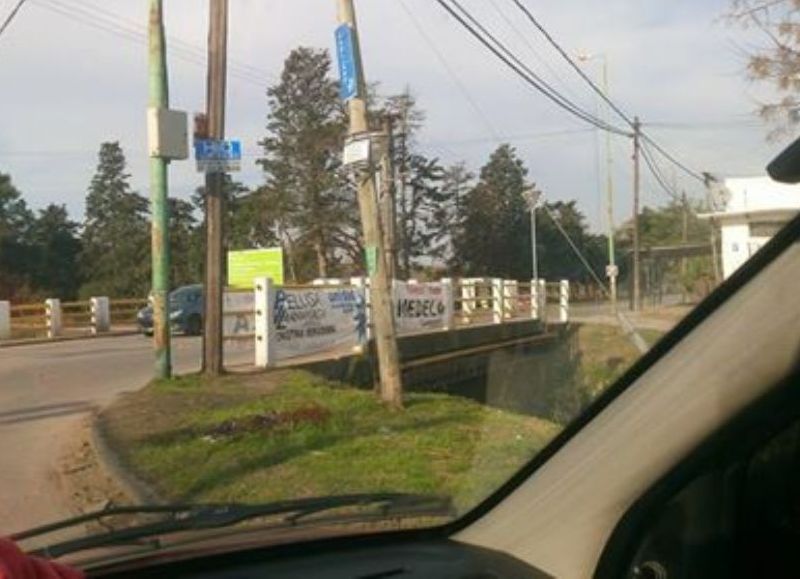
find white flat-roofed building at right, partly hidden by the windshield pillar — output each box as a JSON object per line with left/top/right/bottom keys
{"left": 700, "top": 177, "right": 800, "bottom": 279}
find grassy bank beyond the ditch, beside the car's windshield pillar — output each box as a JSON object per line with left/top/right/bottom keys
{"left": 578, "top": 324, "right": 664, "bottom": 398}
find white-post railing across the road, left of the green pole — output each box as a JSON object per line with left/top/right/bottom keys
{"left": 0, "top": 297, "right": 147, "bottom": 341}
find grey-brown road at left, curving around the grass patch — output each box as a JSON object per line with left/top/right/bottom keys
{"left": 0, "top": 336, "right": 253, "bottom": 536}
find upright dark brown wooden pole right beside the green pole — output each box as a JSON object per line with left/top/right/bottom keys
{"left": 203, "top": 0, "right": 228, "bottom": 376}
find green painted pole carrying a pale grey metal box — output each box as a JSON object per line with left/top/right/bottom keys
{"left": 149, "top": 0, "right": 172, "bottom": 378}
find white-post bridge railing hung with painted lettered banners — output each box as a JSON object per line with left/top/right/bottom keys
{"left": 223, "top": 278, "right": 570, "bottom": 367}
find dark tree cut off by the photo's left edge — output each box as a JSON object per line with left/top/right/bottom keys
{"left": 0, "top": 173, "right": 33, "bottom": 299}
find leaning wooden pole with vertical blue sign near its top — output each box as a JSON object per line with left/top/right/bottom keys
{"left": 337, "top": 0, "right": 403, "bottom": 408}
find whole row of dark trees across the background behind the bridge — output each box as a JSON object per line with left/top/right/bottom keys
{"left": 0, "top": 48, "right": 703, "bottom": 301}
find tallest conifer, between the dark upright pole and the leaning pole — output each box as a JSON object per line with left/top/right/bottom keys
{"left": 258, "top": 48, "right": 357, "bottom": 277}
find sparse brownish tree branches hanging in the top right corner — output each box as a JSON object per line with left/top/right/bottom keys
{"left": 727, "top": 0, "right": 800, "bottom": 138}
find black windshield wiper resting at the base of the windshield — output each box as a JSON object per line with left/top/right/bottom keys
{"left": 12, "top": 493, "right": 455, "bottom": 558}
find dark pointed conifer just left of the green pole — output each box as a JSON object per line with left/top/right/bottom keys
{"left": 81, "top": 142, "right": 150, "bottom": 297}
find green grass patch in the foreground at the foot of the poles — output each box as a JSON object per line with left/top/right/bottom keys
{"left": 101, "top": 372, "right": 558, "bottom": 511}
